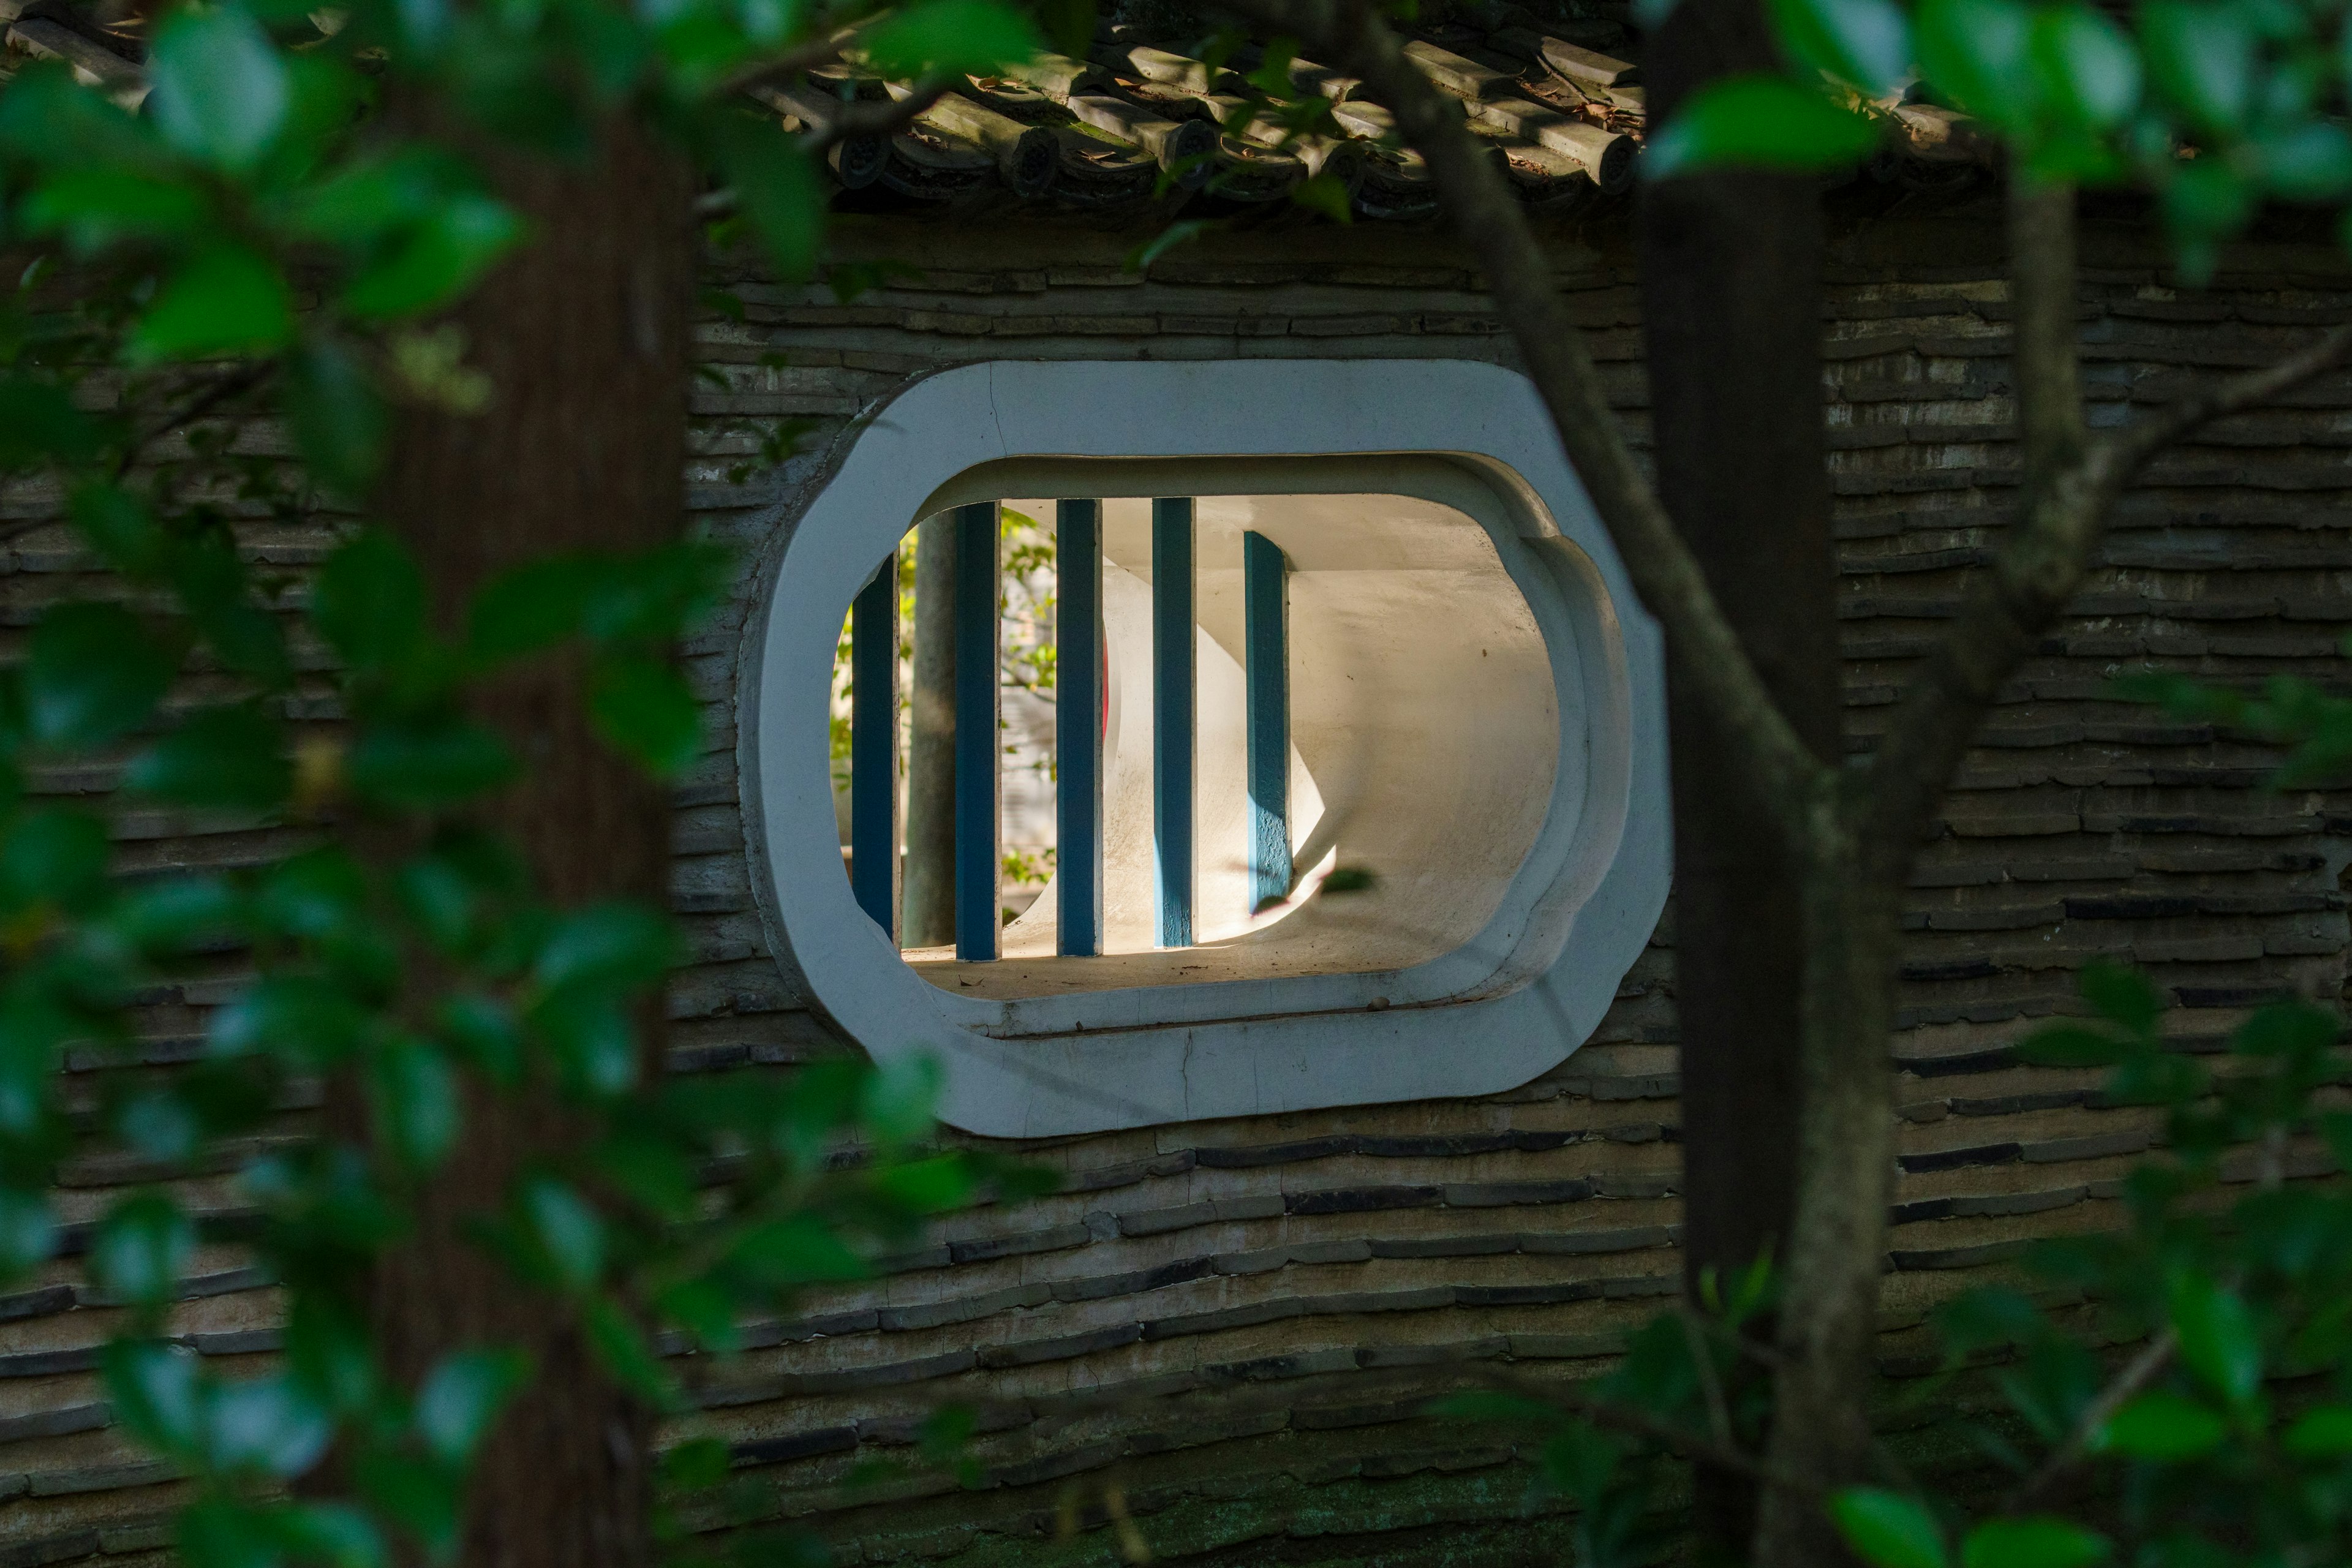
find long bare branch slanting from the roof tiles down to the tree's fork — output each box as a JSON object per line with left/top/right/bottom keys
{"left": 1226, "top": 0, "right": 1834, "bottom": 853}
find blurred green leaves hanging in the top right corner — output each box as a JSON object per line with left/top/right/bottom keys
{"left": 1644, "top": 0, "right": 2352, "bottom": 275}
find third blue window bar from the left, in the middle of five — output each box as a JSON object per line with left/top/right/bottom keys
{"left": 1054, "top": 501, "right": 1103, "bottom": 957}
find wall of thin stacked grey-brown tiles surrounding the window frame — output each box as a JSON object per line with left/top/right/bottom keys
{"left": 0, "top": 205, "right": 2352, "bottom": 1568}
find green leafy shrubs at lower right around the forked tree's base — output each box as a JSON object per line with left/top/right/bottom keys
{"left": 1453, "top": 677, "right": 2352, "bottom": 1568}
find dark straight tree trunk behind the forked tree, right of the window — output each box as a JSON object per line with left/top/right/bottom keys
{"left": 1642, "top": 0, "right": 1839, "bottom": 1563}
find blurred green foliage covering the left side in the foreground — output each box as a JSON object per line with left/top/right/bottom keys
{"left": 0, "top": 0, "right": 1058, "bottom": 1568}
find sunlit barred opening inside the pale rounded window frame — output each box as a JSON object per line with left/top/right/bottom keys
{"left": 835, "top": 491, "right": 1559, "bottom": 997}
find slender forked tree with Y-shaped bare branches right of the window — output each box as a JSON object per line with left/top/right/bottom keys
{"left": 1227, "top": 0, "right": 2352, "bottom": 1568}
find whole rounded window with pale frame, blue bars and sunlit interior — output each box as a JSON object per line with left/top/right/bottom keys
{"left": 745, "top": 362, "right": 1668, "bottom": 1136}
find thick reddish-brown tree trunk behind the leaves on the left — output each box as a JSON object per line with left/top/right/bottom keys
{"left": 357, "top": 118, "right": 694, "bottom": 1568}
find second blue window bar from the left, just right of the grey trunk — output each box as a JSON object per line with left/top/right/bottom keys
{"left": 955, "top": 501, "right": 1000, "bottom": 962}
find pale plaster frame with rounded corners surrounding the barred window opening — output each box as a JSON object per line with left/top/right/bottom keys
{"left": 739, "top": 360, "right": 1670, "bottom": 1138}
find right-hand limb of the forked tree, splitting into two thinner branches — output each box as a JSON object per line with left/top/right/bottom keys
{"left": 1863, "top": 179, "right": 2352, "bottom": 879}
